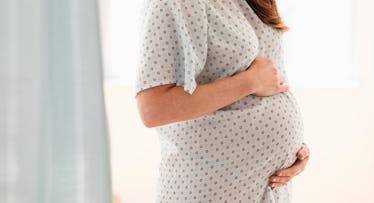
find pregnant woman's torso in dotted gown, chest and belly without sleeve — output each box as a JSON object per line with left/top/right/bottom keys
{"left": 156, "top": 0, "right": 303, "bottom": 202}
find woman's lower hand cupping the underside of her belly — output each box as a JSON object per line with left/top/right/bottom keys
{"left": 269, "top": 144, "right": 310, "bottom": 190}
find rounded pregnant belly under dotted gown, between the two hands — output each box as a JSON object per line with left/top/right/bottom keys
{"left": 157, "top": 92, "right": 303, "bottom": 178}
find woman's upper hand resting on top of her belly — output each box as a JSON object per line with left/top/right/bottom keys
{"left": 239, "top": 57, "right": 289, "bottom": 96}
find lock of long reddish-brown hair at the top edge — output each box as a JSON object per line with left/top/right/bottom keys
{"left": 246, "top": 0, "right": 289, "bottom": 32}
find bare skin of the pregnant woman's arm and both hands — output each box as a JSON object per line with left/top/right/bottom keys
{"left": 135, "top": 57, "right": 309, "bottom": 189}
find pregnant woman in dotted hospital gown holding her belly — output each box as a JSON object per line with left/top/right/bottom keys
{"left": 135, "top": 0, "right": 309, "bottom": 203}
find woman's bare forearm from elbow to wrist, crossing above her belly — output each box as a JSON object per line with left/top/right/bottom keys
{"left": 143, "top": 74, "right": 254, "bottom": 127}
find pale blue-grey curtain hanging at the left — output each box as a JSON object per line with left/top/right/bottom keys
{"left": 0, "top": 0, "right": 112, "bottom": 203}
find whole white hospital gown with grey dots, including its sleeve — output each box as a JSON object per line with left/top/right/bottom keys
{"left": 136, "top": 0, "right": 303, "bottom": 203}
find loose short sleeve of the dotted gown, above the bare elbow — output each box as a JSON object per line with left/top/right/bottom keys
{"left": 135, "top": 0, "right": 208, "bottom": 94}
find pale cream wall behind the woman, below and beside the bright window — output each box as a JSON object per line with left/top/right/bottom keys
{"left": 105, "top": 0, "right": 374, "bottom": 203}
